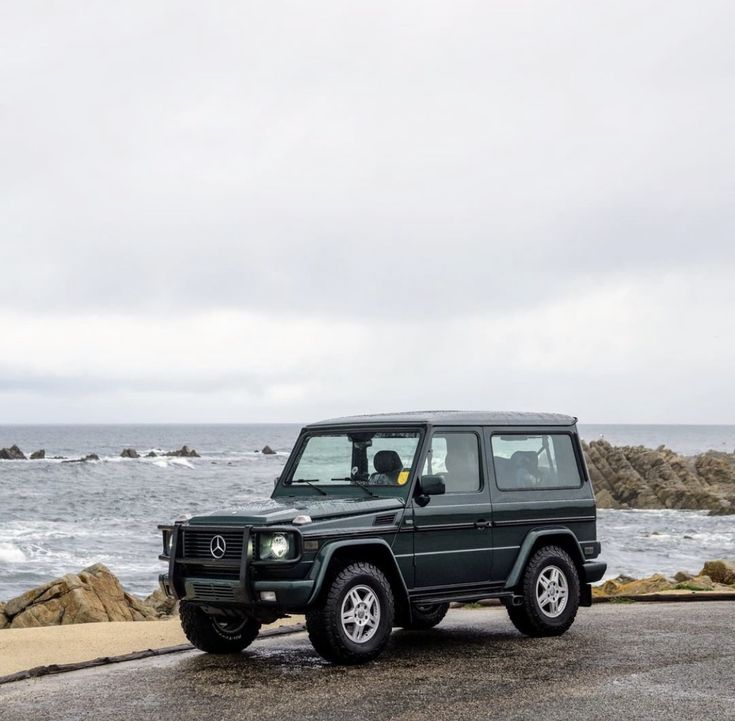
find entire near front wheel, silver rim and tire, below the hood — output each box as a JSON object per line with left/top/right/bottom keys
{"left": 306, "top": 561, "right": 394, "bottom": 664}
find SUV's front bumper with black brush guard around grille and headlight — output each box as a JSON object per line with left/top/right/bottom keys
{"left": 159, "top": 524, "right": 314, "bottom": 609}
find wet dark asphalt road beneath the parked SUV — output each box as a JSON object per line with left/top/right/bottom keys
{"left": 0, "top": 602, "right": 735, "bottom": 721}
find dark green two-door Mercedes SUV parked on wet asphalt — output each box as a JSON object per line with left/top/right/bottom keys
{"left": 160, "top": 411, "right": 606, "bottom": 663}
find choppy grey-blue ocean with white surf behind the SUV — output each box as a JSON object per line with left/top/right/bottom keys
{"left": 0, "top": 424, "right": 735, "bottom": 600}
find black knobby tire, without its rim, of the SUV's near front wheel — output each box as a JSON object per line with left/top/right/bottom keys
{"left": 306, "top": 561, "right": 395, "bottom": 664}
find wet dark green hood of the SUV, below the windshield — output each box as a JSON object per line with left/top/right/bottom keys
{"left": 184, "top": 497, "right": 405, "bottom": 526}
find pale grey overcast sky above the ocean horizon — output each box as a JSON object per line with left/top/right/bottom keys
{"left": 0, "top": 0, "right": 735, "bottom": 423}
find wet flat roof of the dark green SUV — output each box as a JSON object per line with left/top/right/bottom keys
{"left": 307, "top": 411, "right": 577, "bottom": 428}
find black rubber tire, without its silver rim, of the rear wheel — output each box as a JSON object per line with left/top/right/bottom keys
{"left": 507, "top": 546, "right": 580, "bottom": 637}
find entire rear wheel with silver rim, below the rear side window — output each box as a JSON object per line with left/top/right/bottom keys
{"left": 508, "top": 546, "right": 579, "bottom": 636}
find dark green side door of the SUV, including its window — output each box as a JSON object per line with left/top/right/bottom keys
{"left": 411, "top": 427, "right": 492, "bottom": 588}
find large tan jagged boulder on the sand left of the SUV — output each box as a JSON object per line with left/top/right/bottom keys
{"left": 3, "top": 563, "right": 158, "bottom": 628}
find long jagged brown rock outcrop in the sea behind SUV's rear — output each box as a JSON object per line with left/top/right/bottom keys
{"left": 583, "top": 440, "right": 735, "bottom": 514}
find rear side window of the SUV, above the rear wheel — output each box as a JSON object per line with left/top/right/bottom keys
{"left": 490, "top": 433, "right": 582, "bottom": 491}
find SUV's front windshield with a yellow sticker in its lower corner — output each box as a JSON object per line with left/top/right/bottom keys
{"left": 284, "top": 431, "right": 420, "bottom": 495}
